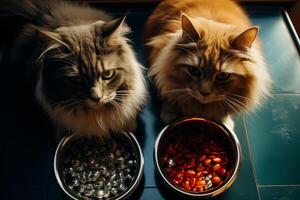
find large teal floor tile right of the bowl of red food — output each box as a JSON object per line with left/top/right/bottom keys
{"left": 247, "top": 95, "right": 300, "bottom": 185}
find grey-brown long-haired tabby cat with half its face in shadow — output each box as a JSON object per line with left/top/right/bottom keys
{"left": 2, "top": 0, "right": 147, "bottom": 137}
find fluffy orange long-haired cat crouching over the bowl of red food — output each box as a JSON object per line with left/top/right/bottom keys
{"left": 145, "top": 0, "right": 270, "bottom": 128}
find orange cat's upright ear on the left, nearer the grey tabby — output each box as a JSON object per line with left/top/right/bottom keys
{"left": 181, "top": 14, "right": 200, "bottom": 42}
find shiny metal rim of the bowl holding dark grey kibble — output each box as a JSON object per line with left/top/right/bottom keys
{"left": 53, "top": 131, "right": 144, "bottom": 200}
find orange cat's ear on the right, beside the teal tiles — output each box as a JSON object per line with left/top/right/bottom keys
{"left": 232, "top": 26, "right": 258, "bottom": 51}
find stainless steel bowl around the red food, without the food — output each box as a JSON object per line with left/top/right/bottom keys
{"left": 154, "top": 117, "right": 241, "bottom": 198}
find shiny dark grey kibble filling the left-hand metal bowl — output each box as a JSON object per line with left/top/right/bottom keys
{"left": 62, "top": 139, "right": 139, "bottom": 199}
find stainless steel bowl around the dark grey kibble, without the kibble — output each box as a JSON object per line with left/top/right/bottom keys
{"left": 54, "top": 132, "right": 144, "bottom": 200}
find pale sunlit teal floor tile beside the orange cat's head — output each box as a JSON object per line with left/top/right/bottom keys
{"left": 251, "top": 10, "right": 300, "bottom": 93}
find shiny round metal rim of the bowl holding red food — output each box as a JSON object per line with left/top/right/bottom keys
{"left": 154, "top": 117, "right": 242, "bottom": 197}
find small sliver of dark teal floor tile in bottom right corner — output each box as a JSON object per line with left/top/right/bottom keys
{"left": 259, "top": 185, "right": 300, "bottom": 200}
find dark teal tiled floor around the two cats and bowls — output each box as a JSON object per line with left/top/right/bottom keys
{"left": 0, "top": 3, "right": 300, "bottom": 200}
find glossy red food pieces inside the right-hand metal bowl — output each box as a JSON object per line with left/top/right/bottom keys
{"left": 163, "top": 135, "right": 228, "bottom": 192}
